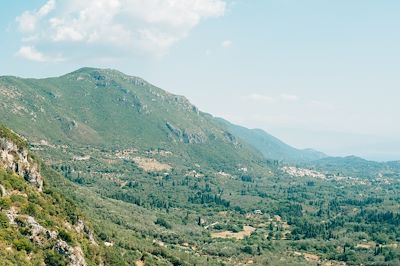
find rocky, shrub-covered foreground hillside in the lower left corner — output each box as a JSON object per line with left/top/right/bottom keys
{"left": 0, "top": 127, "right": 103, "bottom": 266}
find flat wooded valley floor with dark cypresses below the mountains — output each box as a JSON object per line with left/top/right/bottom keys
{"left": 47, "top": 144, "right": 400, "bottom": 265}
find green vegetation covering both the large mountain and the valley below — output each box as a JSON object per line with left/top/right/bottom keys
{"left": 0, "top": 68, "right": 400, "bottom": 265}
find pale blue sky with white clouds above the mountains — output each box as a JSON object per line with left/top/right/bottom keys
{"left": 0, "top": 0, "right": 400, "bottom": 161}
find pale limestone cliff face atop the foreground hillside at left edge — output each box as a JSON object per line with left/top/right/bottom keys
{"left": 0, "top": 138, "right": 43, "bottom": 191}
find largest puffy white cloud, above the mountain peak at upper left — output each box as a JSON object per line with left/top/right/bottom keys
{"left": 17, "top": 0, "right": 226, "bottom": 54}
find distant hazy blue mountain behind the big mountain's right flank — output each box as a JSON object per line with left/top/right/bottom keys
{"left": 219, "top": 119, "right": 327, "bottom": 163}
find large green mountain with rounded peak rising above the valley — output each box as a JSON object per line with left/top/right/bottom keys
{"left": 0, "top": 68, "right": 262, "bottom": 170}
